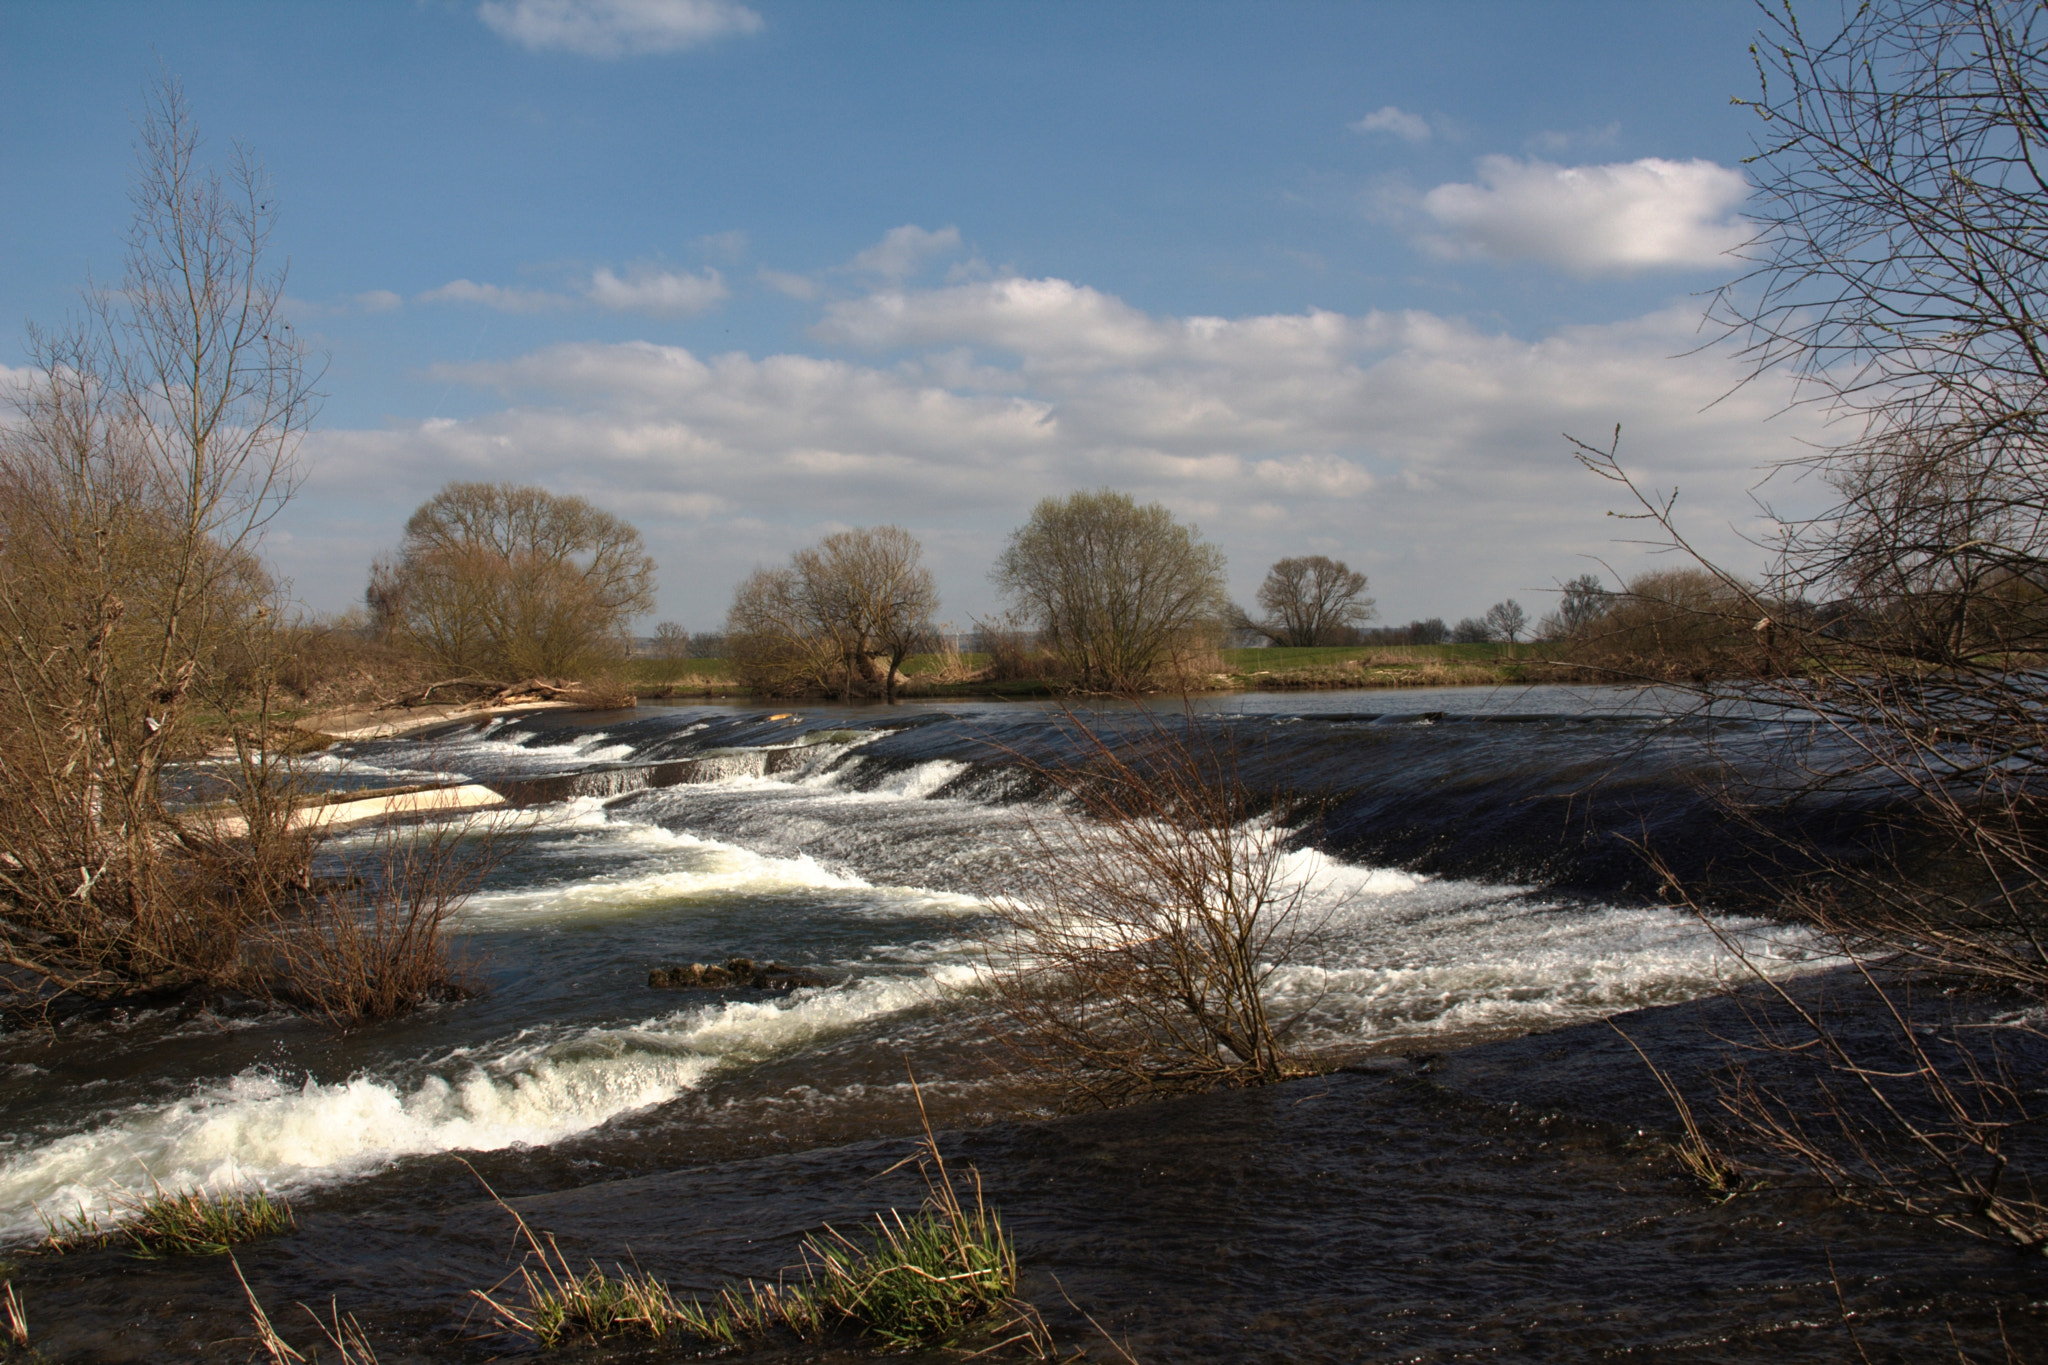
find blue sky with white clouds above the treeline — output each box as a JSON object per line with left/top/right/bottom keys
{"left": 0, "top": 0, "right": 1825, "bottom": 630}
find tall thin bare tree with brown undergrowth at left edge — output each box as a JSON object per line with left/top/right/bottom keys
{"left": 0, "top": 80, "right": 317, "bottom": 1003}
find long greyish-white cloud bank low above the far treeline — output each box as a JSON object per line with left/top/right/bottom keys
{"left": 287, "top": 278, "right": 1815, "bottom": 624}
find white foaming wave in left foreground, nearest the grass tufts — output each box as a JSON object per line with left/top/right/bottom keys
{"left": 0, "top": 968, "right": 958, "bottom": 1240}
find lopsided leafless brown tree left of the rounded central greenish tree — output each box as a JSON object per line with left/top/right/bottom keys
{"left": 725, "top": 526, "right": 938, "bottom": 702}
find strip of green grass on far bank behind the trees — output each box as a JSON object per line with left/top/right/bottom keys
{"left": 616, "top": 645, "right": 1583, "bottom": 700}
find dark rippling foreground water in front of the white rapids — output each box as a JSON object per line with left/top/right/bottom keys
{"left": 14, "top": 978, "right": 2048, "bottom": 1365}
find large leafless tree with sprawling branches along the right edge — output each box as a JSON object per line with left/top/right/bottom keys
{"left": 1577, "top": 0, "right": 2048, "bottom": 1246}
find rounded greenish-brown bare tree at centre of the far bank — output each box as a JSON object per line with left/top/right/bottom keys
{"left": 989, "top": 489, "right": 1229, "bottom": 690}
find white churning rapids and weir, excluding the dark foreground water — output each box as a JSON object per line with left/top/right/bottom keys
{"left": 0, "top": 688, "right": 2023, "bottom": 1359}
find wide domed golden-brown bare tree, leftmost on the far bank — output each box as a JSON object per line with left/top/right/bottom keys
{"left": 367, "top": 483, "right": 653, "bottom": 677}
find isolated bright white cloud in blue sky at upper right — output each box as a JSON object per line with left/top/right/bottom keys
{"left": 1419, "top": 156, "right": 1751, "bottom": 274}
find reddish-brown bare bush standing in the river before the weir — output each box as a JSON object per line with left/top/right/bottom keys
{"left": 987, "top": 714, "right": 1327, "bottom": 1105}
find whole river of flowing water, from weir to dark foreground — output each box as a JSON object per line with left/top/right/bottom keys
{"left": 0, "top": 688, "right": 2048, "bottom": 1365}
